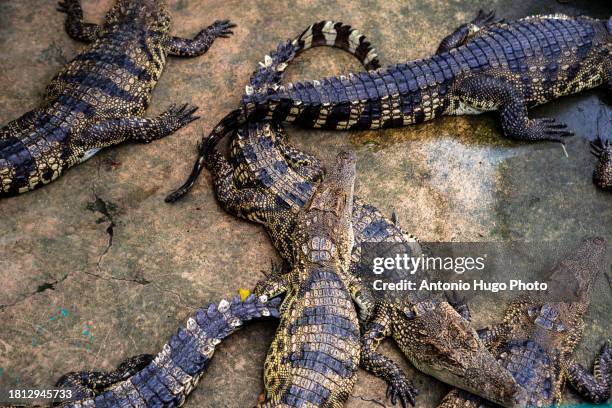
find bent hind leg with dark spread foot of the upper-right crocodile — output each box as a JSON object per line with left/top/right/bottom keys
{"left": 451, "top": 74, "right": 573, "bottom": 143}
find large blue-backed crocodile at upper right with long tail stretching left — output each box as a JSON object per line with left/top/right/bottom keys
{"left": 166, "top": 13, "right": 612, "bottom": 202}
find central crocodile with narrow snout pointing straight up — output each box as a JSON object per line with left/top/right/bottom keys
{"left": 253, "top": 152, "right": 361, "bottom": 408}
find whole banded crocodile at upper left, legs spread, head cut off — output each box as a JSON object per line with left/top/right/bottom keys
{"left": 0, "top": 0, "right": 234, "bottom": 197}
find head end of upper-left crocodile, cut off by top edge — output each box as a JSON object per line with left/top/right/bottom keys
{"left": 105, "top": 0, "right": 172, "bottom": 33}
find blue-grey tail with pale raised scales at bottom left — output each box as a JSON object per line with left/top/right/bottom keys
{"left": 57, "top": 294, "right": 280, "bottom": 408}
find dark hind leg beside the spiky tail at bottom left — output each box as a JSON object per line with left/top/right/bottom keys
{"left": 56, "top": 354, "right": 155, "bottom": 399}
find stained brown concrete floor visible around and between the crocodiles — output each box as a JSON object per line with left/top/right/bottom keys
{"left": 0, "top": 0, "right": 612, "bottom": 407}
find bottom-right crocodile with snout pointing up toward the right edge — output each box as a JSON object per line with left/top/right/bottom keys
{"left": 439, "top": 237, "right": 612, "bottom": 408}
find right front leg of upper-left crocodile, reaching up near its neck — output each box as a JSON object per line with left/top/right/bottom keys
{"left": 166, "top": 20, "right": 236, "bottom": 57}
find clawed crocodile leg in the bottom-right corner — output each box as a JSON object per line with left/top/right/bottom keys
{"left": 567, "top": 342, "right": 612, "bottom": 404}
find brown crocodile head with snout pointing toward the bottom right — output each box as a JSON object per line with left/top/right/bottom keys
{"left": 393, "top": 301, "right": 526, "bottom": 407}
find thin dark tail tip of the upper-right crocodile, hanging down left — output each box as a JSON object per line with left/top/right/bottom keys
{"left": 165, "top": 109, "right": 246, "bottom": 203}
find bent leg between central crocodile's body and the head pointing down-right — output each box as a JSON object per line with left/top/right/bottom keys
{"left": 361, "top": 305, "right": 418, "bottom": 408}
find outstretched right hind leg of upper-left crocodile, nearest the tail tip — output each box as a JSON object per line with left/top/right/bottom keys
{"left": 75, "top": 104, "right": 198, "bottom": 151}
